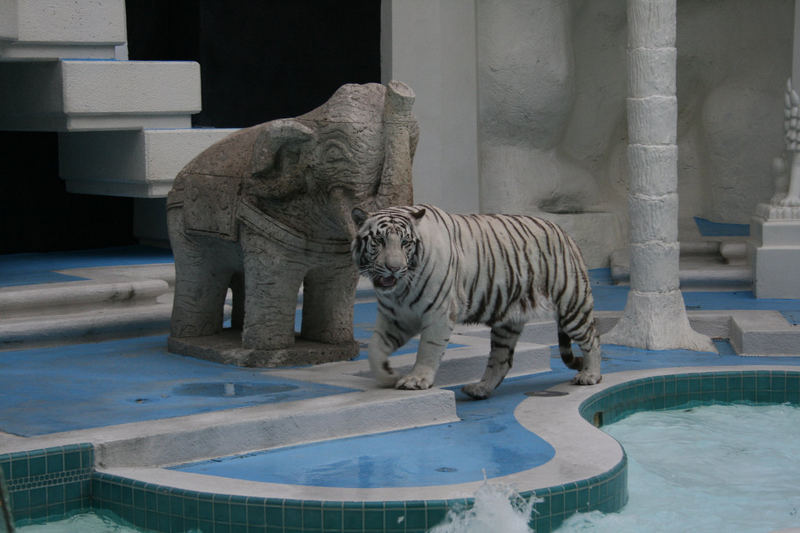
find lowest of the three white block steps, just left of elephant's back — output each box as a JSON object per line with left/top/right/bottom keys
{"left": 58, "top": 128, "right": 237, "bottom": 198}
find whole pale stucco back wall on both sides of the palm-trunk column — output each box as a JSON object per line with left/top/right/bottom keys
{"left": 382, "top": 0, "right": 794, "bottom": 266}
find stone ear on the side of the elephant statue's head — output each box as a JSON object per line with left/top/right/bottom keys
{"left": 250, "top": 119, "right": 316, "bottom": 198}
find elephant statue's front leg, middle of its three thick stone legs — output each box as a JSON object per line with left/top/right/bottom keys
{"left": 242, "top": 231, "right": 308, "bottom": 350}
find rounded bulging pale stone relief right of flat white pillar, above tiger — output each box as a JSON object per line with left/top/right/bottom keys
{"left": 476, "top": 0, "right": 600, "bottom": 213}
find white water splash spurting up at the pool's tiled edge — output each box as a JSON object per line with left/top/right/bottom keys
{"left": 429, "top": 481, "right": 541, "bottom": 533}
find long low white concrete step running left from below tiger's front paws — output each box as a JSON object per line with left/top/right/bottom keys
{"left": 0, "top": 380, "right": 459, "bottom": 468}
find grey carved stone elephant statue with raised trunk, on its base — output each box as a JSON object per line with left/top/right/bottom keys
{"left": 167, "top": 81, "right": 419, "bottom": 366}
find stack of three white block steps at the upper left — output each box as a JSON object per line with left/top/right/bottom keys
{"left": 0, "top": 0, "right": 234, "bottom": 198}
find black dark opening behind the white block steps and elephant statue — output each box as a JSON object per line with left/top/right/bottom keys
{"left": 0, "top": 0, "right": 380, "bottom": 253}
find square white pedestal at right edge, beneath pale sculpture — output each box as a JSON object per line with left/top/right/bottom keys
{"left": 747, "top": 204, "right": 800, "bottom": 298}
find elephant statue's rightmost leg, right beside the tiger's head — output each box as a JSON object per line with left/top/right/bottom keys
{"left": 300, "top": 261, "right": 358, "bottom": 344}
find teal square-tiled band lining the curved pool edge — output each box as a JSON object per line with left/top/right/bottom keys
{"left": 6, "top": 369, "right": 800, "bottom": 533}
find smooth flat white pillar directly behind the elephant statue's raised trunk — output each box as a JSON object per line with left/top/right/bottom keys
{"left": 381, "top": 0, "right": 479, "bottom": 212}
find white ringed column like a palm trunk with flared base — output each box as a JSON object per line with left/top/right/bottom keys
{"left": 603, "top": 0, "right": 714, "bottom": 351}
